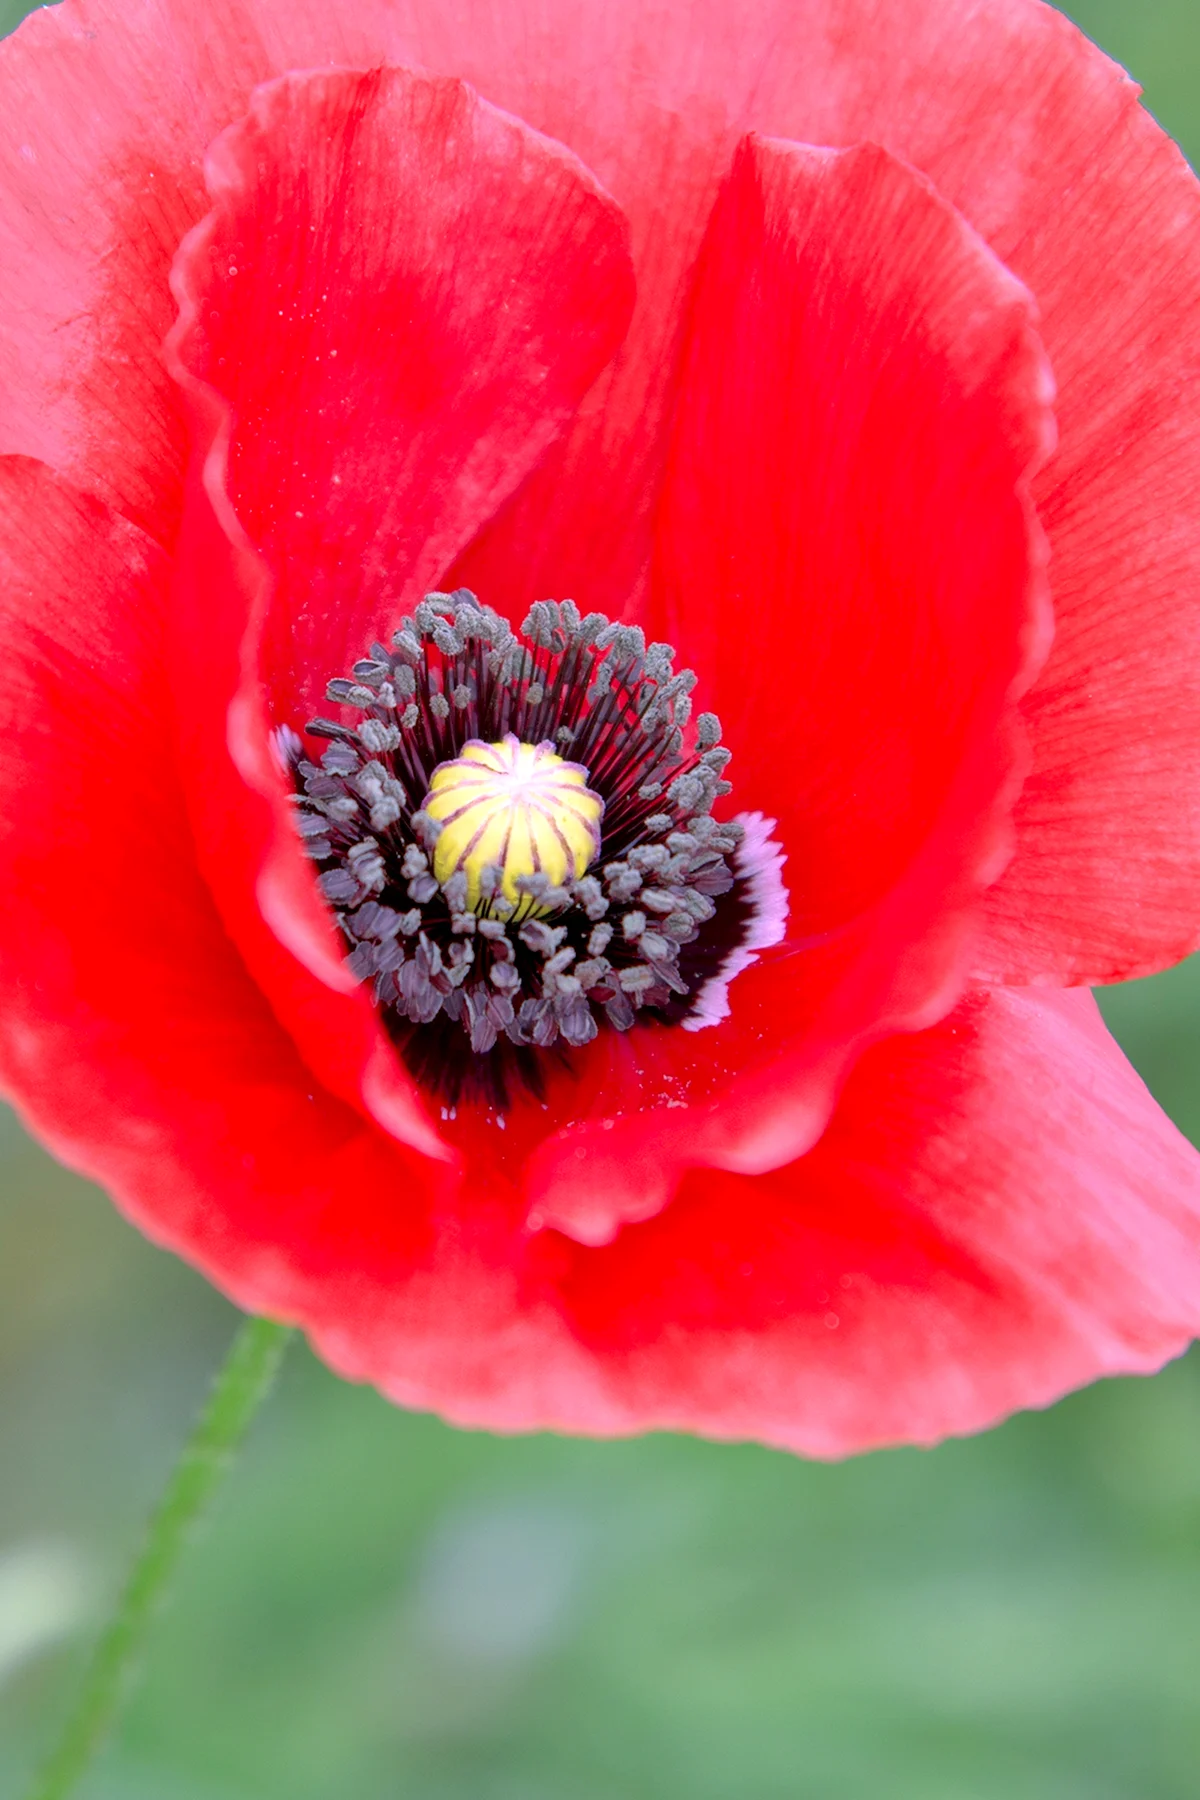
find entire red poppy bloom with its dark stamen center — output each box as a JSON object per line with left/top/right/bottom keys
{"left": 0, "top": 0, "right": 1200, "bottom": 1454}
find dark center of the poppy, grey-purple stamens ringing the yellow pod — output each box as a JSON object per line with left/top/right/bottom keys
{"left": 277, "top": 589, "right": 786, "bottom": 1109}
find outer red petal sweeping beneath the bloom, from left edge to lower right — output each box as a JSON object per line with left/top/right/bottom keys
{"left": 0, "top": 478, "right": 1200, "bottom": 1454}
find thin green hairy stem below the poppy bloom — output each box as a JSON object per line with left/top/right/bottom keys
{"left": 29, "top": 1319, "right": 291, "bottom": 1800}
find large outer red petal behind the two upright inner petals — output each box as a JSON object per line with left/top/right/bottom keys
{"left": 0, "top": 0, "right": 1200, "bottom": 979}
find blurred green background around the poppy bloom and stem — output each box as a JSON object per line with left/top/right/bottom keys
{"left": 0, "top": 0, "right": 1200, "bottom": 1800}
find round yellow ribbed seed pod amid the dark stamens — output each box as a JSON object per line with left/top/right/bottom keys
{"left": 421, "top": 731, "right": 604, "bottom": 914}
